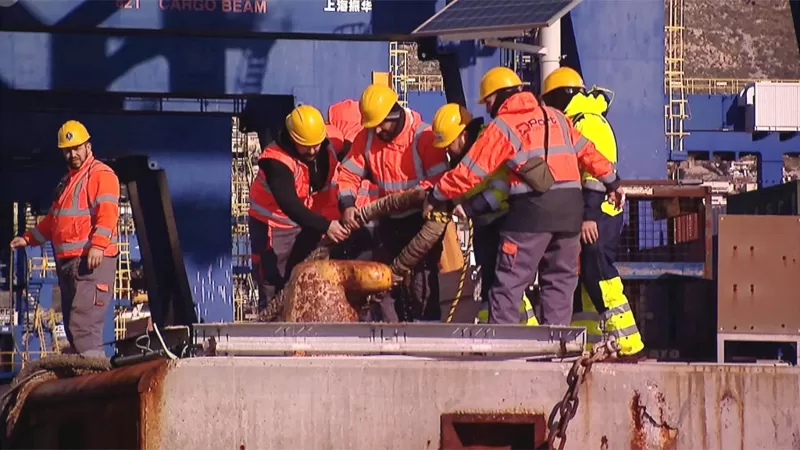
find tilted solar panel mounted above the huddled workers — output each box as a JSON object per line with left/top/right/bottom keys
{"left": 411, "top": 0, "right": 581, "bottom": 37}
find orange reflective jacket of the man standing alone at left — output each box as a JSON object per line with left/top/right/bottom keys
{"left": 23, "top": 156, "right": 119, "bottom": 259}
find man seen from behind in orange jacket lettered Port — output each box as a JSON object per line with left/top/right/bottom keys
{"left": 425, "top": 67, "right": 623, "bottom": 325}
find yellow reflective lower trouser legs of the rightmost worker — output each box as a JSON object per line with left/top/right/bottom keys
{"left": 572, "top": 277, "right": 644, "bottom": 355}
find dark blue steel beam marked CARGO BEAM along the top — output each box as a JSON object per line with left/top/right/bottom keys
{"left": 0, "top": 0, "right": 444, "bottom": 40}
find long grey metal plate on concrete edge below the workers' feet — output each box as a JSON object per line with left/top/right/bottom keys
{"left": 194, "top": 323, "right": 586, "bottom": 358}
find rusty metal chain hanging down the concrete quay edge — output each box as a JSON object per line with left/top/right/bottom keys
{"left": 547, "top": 337, "right": 619, "bottom": 450}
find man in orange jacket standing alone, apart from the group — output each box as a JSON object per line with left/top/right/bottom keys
{"left": 11, "top": 120, "right": 119, "bottom": 357}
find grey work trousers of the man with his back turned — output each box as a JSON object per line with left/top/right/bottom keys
{"left": 489, "top": 231, "right": 581, "bottom": 325}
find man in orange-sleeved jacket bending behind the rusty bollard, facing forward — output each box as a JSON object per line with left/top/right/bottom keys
{"left": 337, "top": 84, "right": 447, "bottom": 322}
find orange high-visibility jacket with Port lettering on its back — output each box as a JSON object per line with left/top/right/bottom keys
{"left": 431, "top": 92, "right": 619, "bottom": 231}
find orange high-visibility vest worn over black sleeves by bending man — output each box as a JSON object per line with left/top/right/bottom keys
{"left": 249, "top": 132, "right": 340, "bottom": 228}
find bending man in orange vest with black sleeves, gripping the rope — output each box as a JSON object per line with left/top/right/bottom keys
{"left": 249, "top": 105, "right": 349, "bottom": 310}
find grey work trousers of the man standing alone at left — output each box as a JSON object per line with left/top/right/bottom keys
{"left": 56, "top": 256, "right": 117, "bottom": 357}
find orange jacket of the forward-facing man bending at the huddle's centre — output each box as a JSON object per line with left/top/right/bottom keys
{"left": 336, "top": 110, "right": 448, "bottom": 212}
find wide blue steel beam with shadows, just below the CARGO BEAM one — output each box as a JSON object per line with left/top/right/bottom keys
{"left": 0, "top": 31, "right": 389, "bottom": 98}
